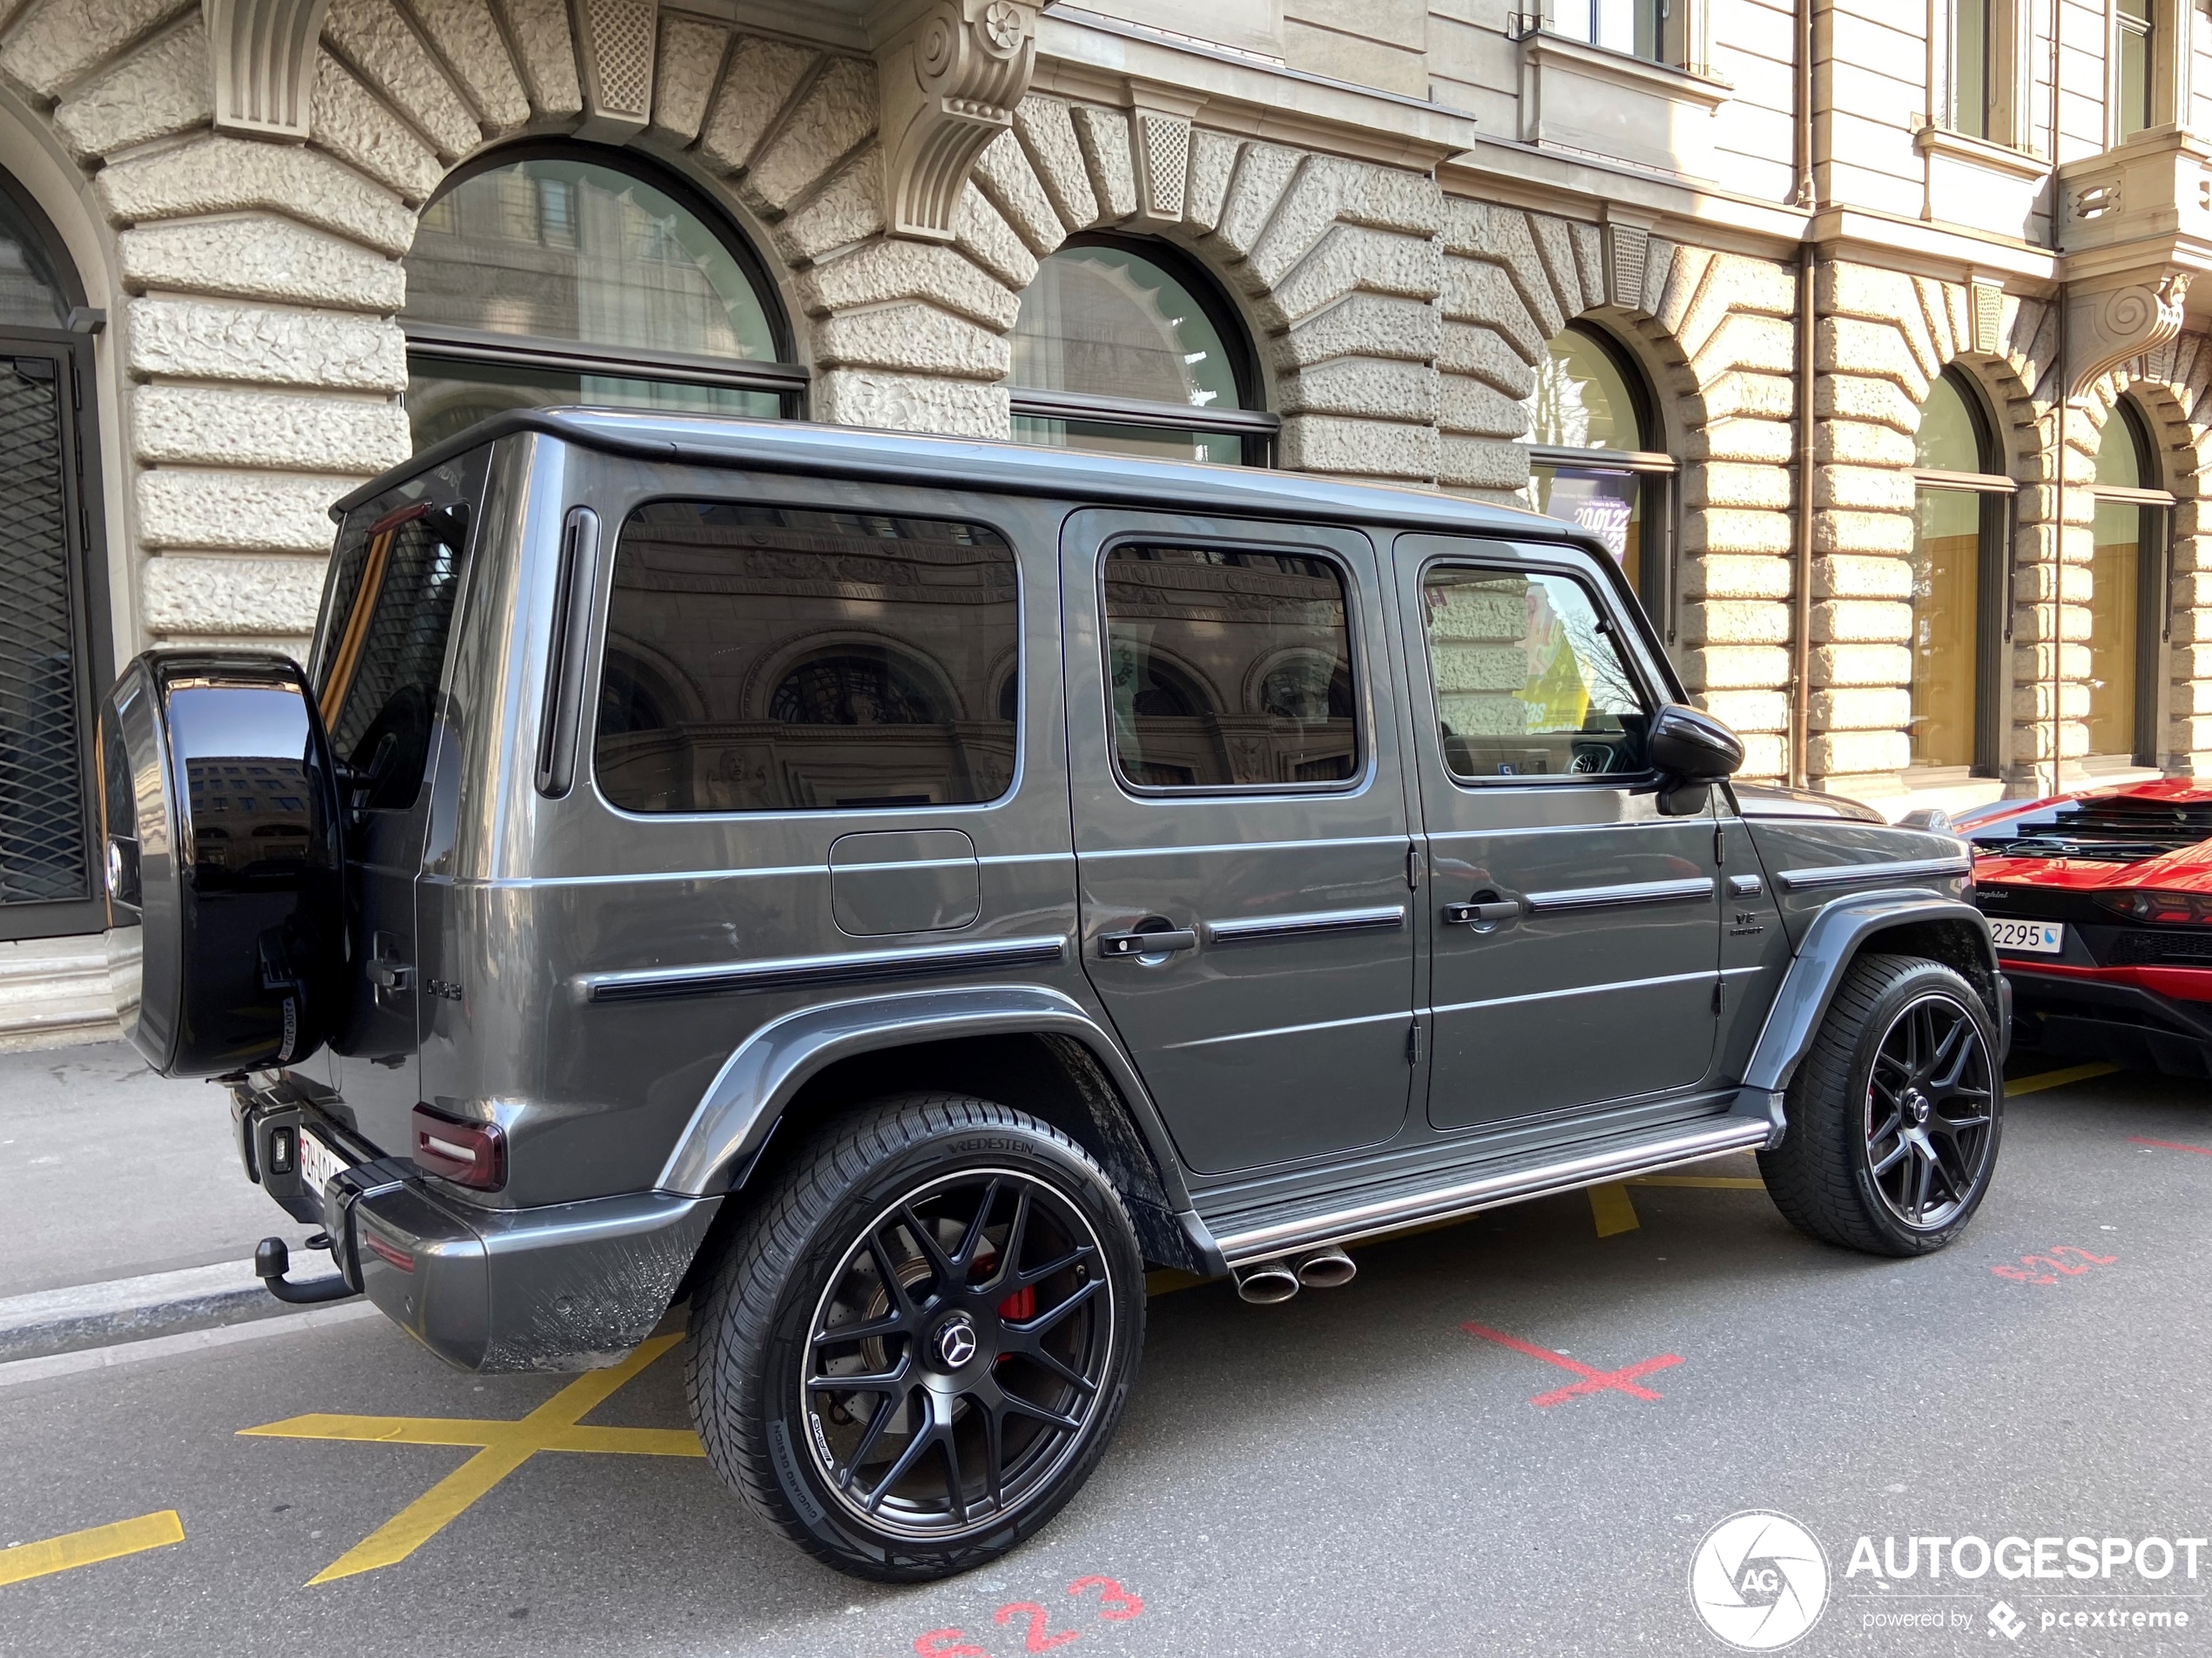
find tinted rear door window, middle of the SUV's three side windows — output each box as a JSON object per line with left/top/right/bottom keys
{"left": 1106, "top": 546, "right": 1359, "bottom": 789}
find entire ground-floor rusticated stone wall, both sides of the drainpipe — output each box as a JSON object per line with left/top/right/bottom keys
{"left": 0, "top": 0, "right": 2212, "bottom": 831}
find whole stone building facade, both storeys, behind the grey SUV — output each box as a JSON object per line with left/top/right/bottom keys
{"left": 0, "top": 0, "right": 2212, "bottom": 1043}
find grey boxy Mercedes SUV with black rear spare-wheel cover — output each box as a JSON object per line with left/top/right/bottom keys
{"left": 102, "top": 411, "right": 2006, "bottom": 1579}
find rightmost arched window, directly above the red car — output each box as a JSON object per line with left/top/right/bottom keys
{"left": 2088, "top": 400, "right": 2175, "bottom": 765}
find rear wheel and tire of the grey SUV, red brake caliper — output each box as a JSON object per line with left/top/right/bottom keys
{"left": 685, "top": 1095, "right": 1143, "bottom": 1583}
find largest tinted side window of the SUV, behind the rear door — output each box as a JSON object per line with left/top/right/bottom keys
{"left": 595, "top": 502, "right": 1020, "bottom": 812}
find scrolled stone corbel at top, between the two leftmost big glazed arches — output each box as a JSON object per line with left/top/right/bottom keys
{"left": 878, "top": 0, "right": 1037, "bottom": 241}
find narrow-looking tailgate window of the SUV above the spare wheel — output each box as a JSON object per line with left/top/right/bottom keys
{"left": 316, "top": 502, "right": 467, "bottom": 809}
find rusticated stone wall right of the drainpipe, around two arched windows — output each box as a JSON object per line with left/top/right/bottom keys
{"left": 1810, "top": 261, "right": 2212, "bottom": 793}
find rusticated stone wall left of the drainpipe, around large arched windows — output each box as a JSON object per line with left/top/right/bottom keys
{"left": 0, "top": 0, "right": 1790, "bottom": 774}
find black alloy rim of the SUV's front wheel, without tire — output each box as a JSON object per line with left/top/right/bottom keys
{"left": 1865, "top": 994, "right": 1995, "bottom": 1231}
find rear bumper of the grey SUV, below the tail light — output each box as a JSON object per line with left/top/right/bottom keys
{"left": 233, "top": 1085, "right": 721, "bottom": 1371}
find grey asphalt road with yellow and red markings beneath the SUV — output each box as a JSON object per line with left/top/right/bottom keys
{"left": 0, "top": 1076, "right": 2212, "bottom": 1658}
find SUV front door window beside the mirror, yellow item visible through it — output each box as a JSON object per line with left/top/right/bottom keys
{"left": 1420, "top": 566, "right": 1650, "bottom": 780}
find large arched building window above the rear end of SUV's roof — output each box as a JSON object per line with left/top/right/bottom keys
{"left": 401, "top": 146, "right": 806, "bottom": 447}
